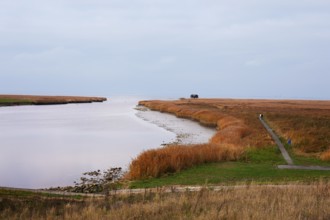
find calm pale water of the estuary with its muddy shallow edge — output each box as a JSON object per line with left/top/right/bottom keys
{"left": 0, "top": 98, "right": 214, "bottom": 188}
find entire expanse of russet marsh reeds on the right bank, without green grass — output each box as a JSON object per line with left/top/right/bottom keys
{"left": 129, "top": 99, "right": 330, "bottom": 179}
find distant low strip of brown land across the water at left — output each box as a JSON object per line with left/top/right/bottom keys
{"left": 0, "top": 95, "right": 107, "bottom": 106}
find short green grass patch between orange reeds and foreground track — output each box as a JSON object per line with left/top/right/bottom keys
{"left": 130, "top": 146, "right": 330, "bottom": 188}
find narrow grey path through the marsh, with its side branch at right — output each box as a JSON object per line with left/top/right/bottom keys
{"left": 259, "top": 117, "right": 330, "bottom": 170}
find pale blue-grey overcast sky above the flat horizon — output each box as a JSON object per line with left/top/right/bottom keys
{"left": 0, "top": 0, "right": 330, "bottom": 99}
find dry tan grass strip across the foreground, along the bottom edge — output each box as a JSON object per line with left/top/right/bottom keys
{"left": 0, "top": 181, "right": 330, "bottom": 220}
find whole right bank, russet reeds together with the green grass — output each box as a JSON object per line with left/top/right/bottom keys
{"left": 129, "top": 99, "right": 330, "bottom": 187}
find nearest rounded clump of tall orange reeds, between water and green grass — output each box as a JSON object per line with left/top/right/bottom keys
{"left": 128, "top": 144, "right": 243, "bottom": 179}
